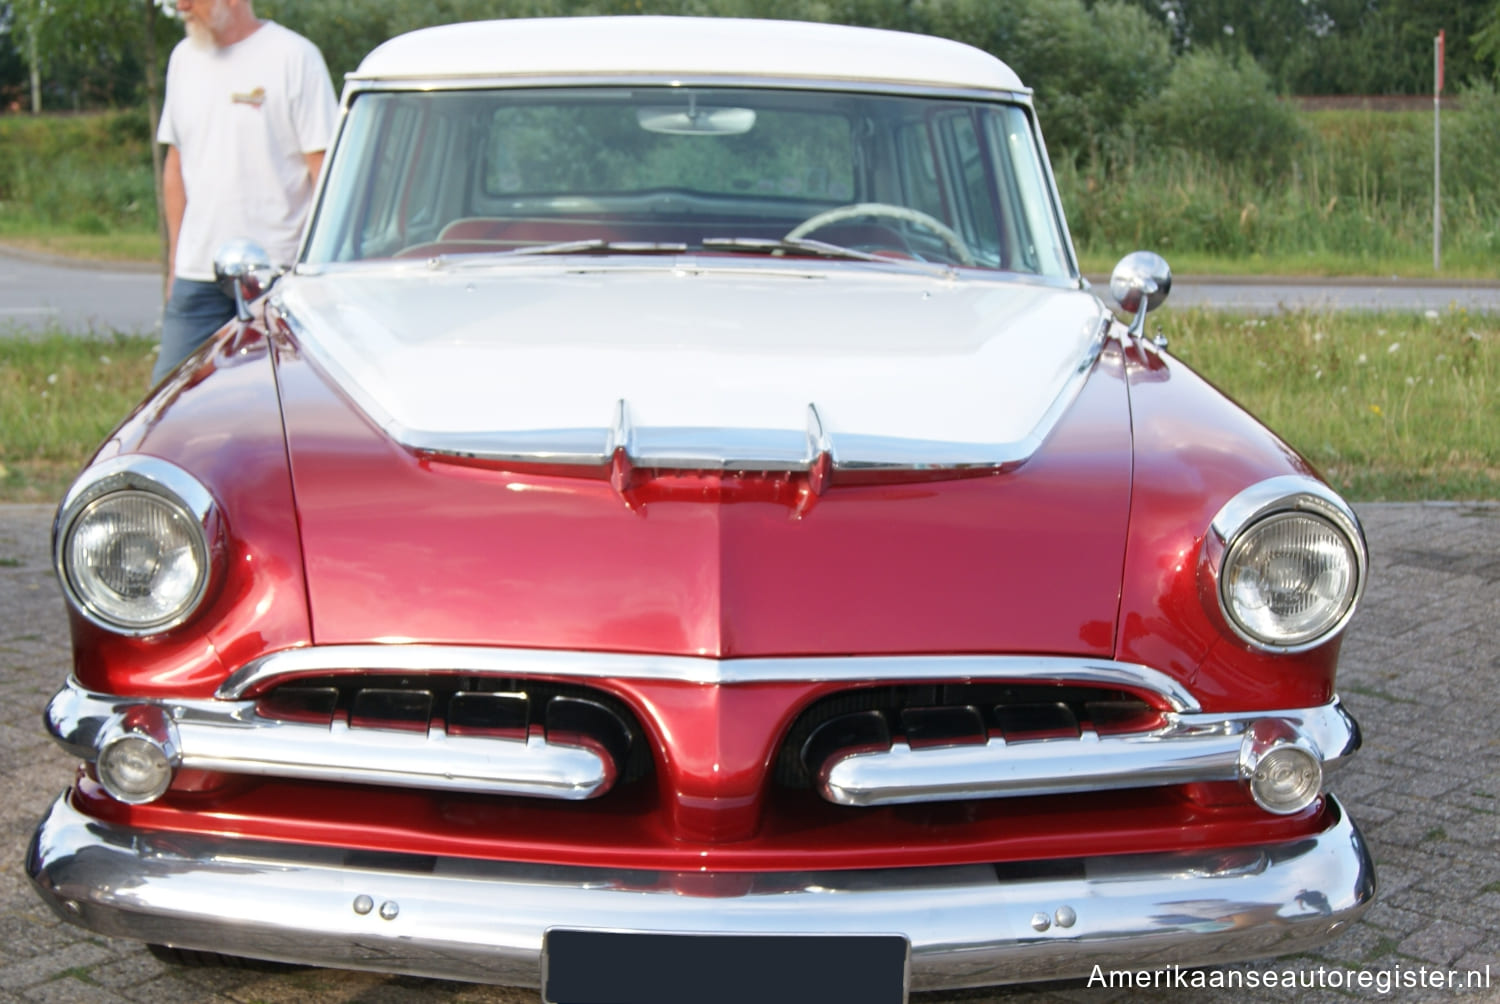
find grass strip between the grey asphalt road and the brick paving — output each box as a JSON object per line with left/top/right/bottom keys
{"left": 0, "top": 309, "right": 1500, "bottom": 503}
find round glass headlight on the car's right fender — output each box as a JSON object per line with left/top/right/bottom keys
{"left": 1220, "top": 512, "right": 1359, "bottom": 648}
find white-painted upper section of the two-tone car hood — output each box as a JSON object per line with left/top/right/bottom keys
{"left": 282, "top": 258, "right": 1104, "bottom": 470}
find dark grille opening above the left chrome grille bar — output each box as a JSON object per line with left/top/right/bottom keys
{"left": 255, "top": 674, "right": 653, "bottom": 786}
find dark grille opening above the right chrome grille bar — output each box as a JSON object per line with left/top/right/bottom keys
{"left": 774, "top": 683, "right": 1163, "bottom": 788}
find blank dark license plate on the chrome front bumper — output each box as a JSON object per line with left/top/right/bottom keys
{"left": 542, "top": 927, "right": 909, "bottom": 1004}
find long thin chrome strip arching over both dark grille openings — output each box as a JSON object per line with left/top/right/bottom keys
{"left": 215, "top": 644, "right": 1199, "bottom": 711}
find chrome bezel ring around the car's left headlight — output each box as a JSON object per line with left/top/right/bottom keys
{"left": 53, "top": 453, "right": 224, "bottom": 638}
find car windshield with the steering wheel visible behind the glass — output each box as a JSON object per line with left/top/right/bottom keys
{"left": 305, "top": 87, "right": 1073, "bottom": 278}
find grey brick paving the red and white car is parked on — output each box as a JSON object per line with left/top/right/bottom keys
{"left": 0, "top": 504, "right": 1500, "bottom": 1004}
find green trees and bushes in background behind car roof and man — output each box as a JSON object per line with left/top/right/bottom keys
{"left": 0, "top": 0, "right": 1500, "bottom": 179}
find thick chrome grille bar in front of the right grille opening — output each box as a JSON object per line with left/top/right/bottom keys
{"left": 818, "top": 699, "right": 1359, "bottom": 806}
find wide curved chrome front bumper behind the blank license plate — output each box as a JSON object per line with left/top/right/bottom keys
{"left": 27, "top": 795, "right": 1376, "bottom": 990}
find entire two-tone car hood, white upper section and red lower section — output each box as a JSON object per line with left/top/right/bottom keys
{"left": 273, "top": 263, "right": 1131, "bottom": 657}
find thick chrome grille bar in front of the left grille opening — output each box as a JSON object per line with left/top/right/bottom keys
{"left": 45, "top": 680, "right": 617, "bottom": 801}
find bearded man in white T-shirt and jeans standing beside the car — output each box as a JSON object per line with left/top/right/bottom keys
{"left": 152, "top": 0, "right": 338, "bottom": 380}
